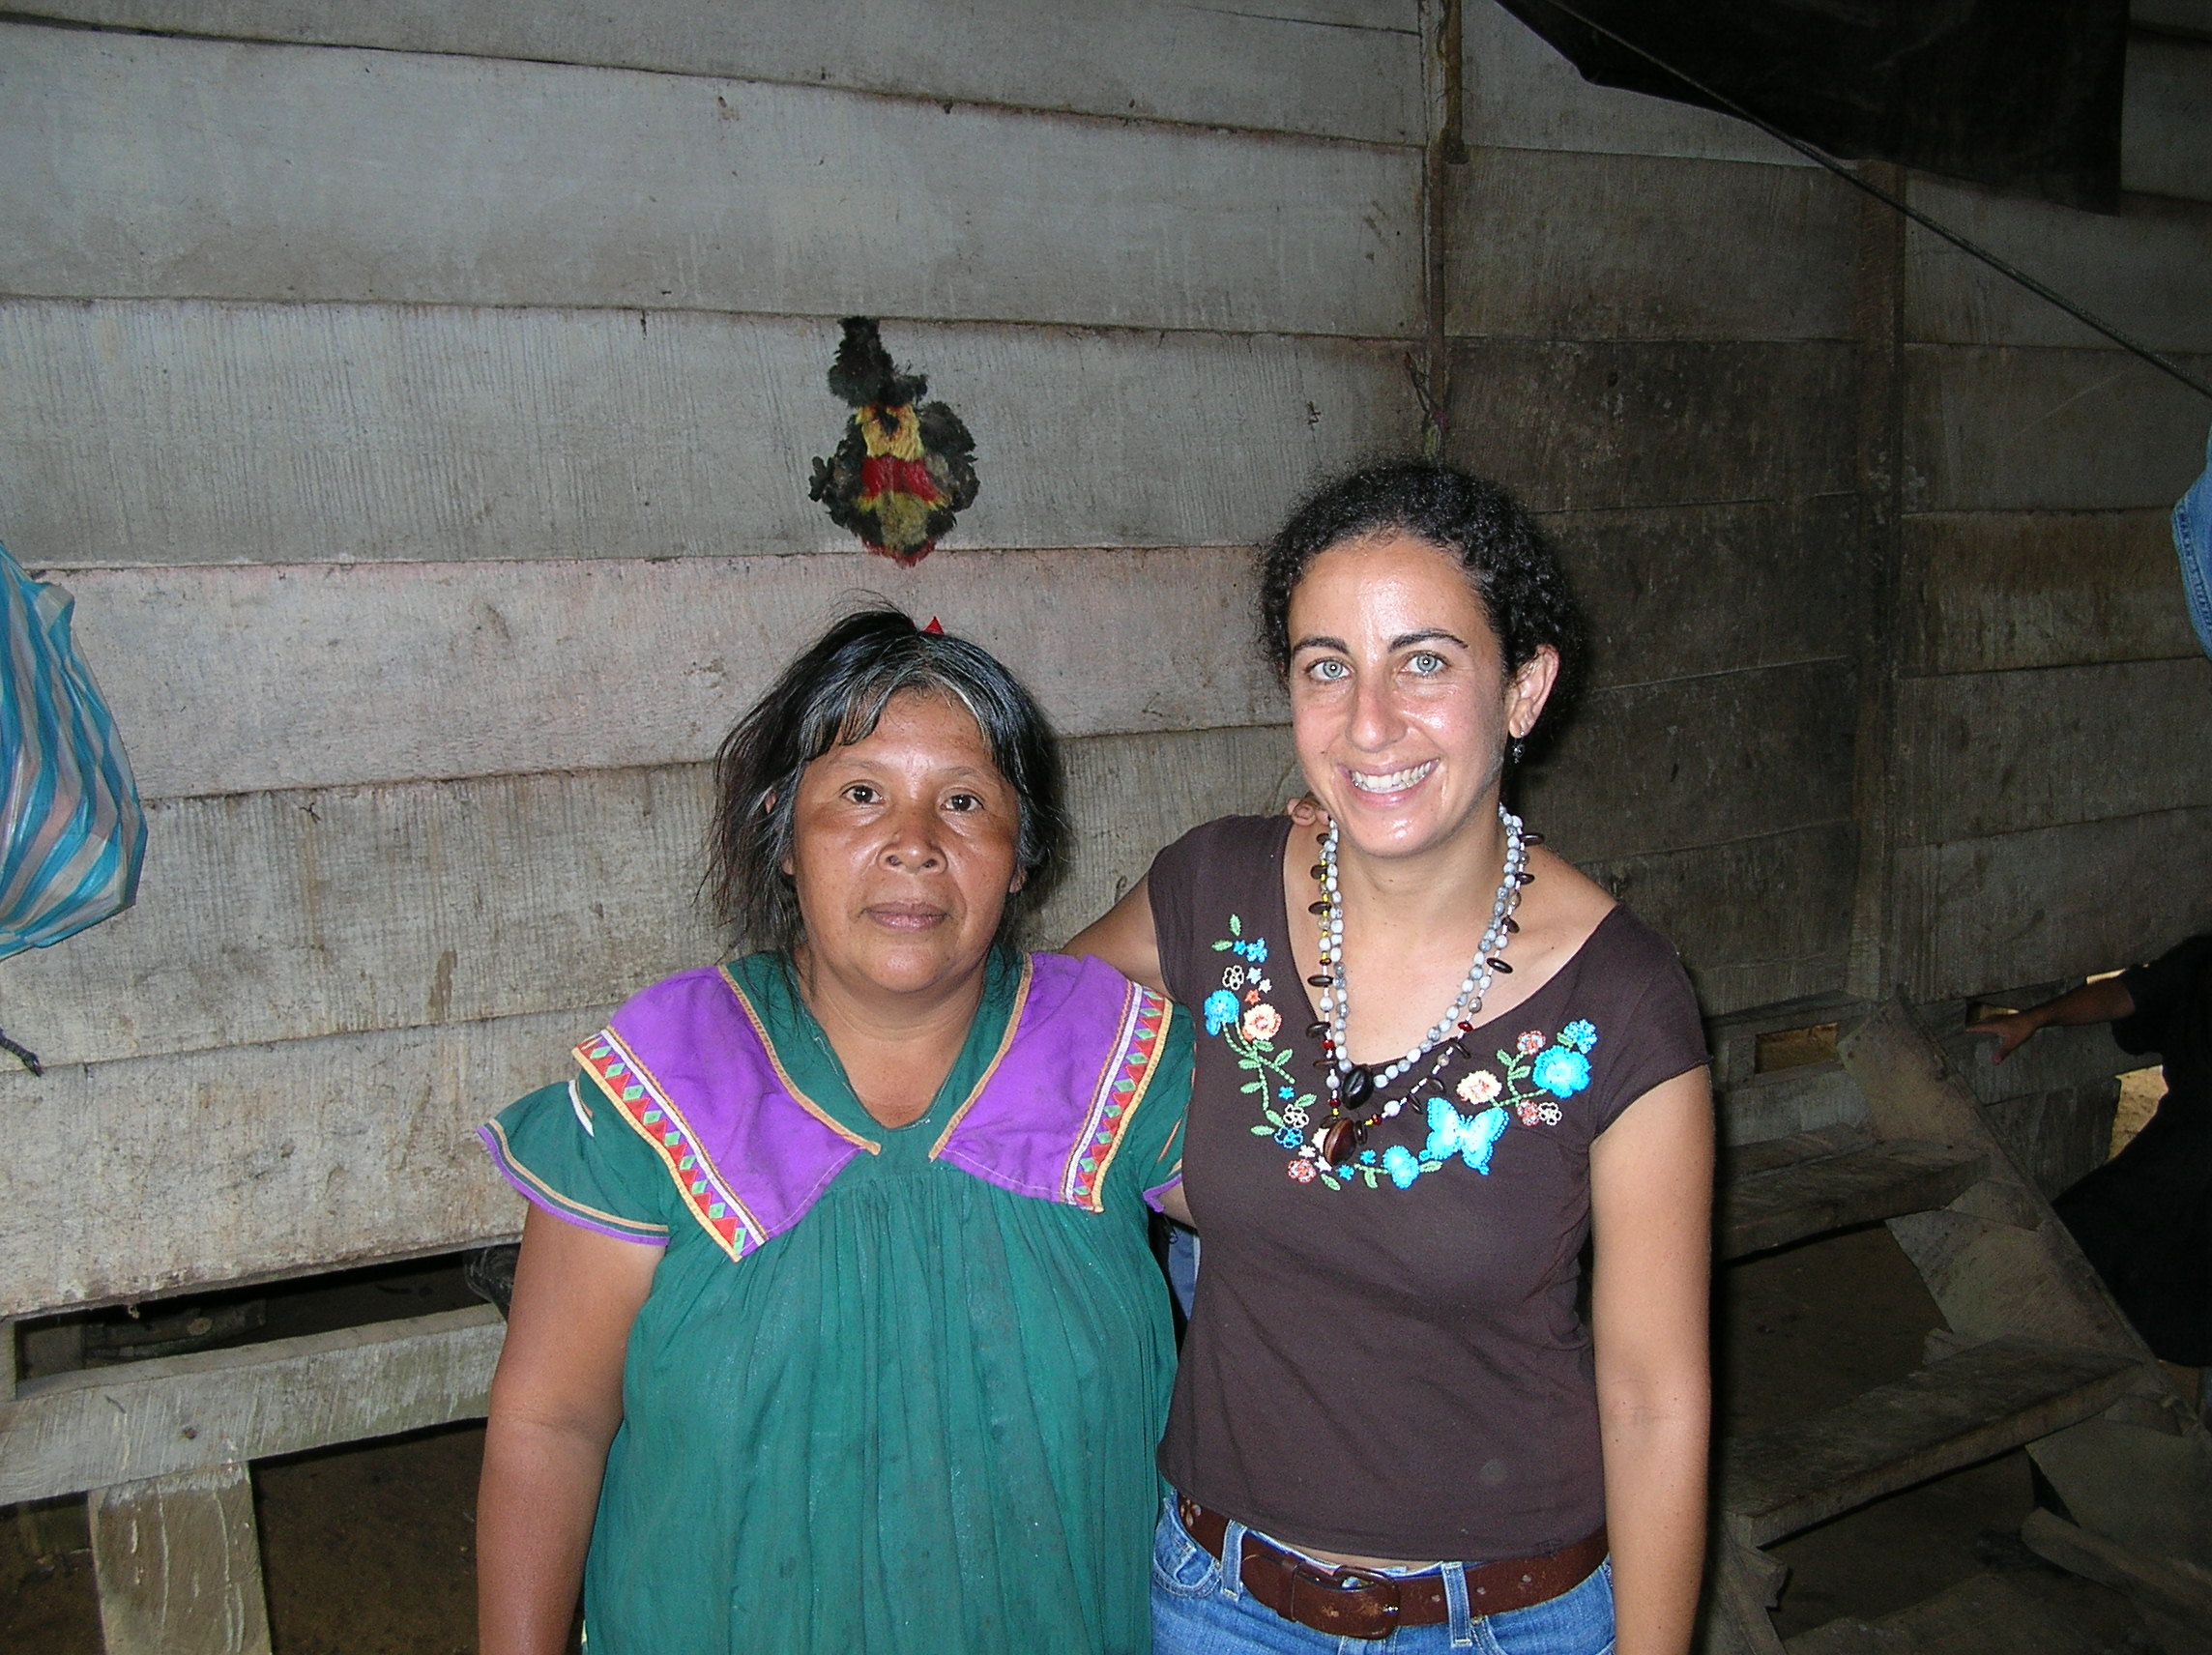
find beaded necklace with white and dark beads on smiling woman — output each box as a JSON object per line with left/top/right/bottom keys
{"left": 1307, "top": 803, "right": 1542, "bottom": 1164}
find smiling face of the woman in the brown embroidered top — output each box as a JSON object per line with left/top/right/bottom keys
{"left": 1290, "top": 534, "right": 1559, "bottom": 858}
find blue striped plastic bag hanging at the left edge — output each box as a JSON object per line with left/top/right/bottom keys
{"left": 0, "top": 546, "right": 146, "bottom": 982}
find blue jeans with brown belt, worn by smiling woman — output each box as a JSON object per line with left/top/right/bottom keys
{"left": 1152, "top": 1495, "right": 1613, "bottom": 1655}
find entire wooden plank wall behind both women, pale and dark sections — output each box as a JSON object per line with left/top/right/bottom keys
{"left": 0, "top": 0, "right": 2212, "bottom": 1315}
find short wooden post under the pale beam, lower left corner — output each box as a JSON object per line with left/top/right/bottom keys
{"left": 91, "top": 1465, "right": 270, "bottom": 1655}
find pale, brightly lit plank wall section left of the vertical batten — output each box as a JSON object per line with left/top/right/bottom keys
{"left": 0, "top": 0, "right": 1422, "bottom": 1315}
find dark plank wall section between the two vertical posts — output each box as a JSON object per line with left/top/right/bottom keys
{"left": 1449, "top": 5, "right": 1860, "bottom": 1013}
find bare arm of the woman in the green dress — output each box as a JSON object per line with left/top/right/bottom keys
{"left": 476, "top": 1205, "right": 661, "bottom": 1655}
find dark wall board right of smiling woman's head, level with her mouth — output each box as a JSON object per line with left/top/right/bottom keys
{"left": 1513, "top": 661, "right": 1856, "bottom": 860}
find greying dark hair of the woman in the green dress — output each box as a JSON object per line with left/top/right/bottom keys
{"left": 704, "top": 608, "right": 1068, "bottom": 953}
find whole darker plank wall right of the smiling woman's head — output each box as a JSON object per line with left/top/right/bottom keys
{"left": 1446, "top": 0, "right": 2212, "bottom": 1013}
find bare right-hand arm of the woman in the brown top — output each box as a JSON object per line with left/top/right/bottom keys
{"left": 1590, "top": 1068, "right": 1712, "bottom": 1655}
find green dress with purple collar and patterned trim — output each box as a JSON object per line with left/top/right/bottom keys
{"left": 486, "top": 953, "right": 1192, "bottom": 1655}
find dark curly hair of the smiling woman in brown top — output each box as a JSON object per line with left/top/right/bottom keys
{"left": 1259, "top": 460, "right": 1582, "bottom": 711}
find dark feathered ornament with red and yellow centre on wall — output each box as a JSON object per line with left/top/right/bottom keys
{"left": 807, "top": 316, "right": 975, "bottom": 568}
